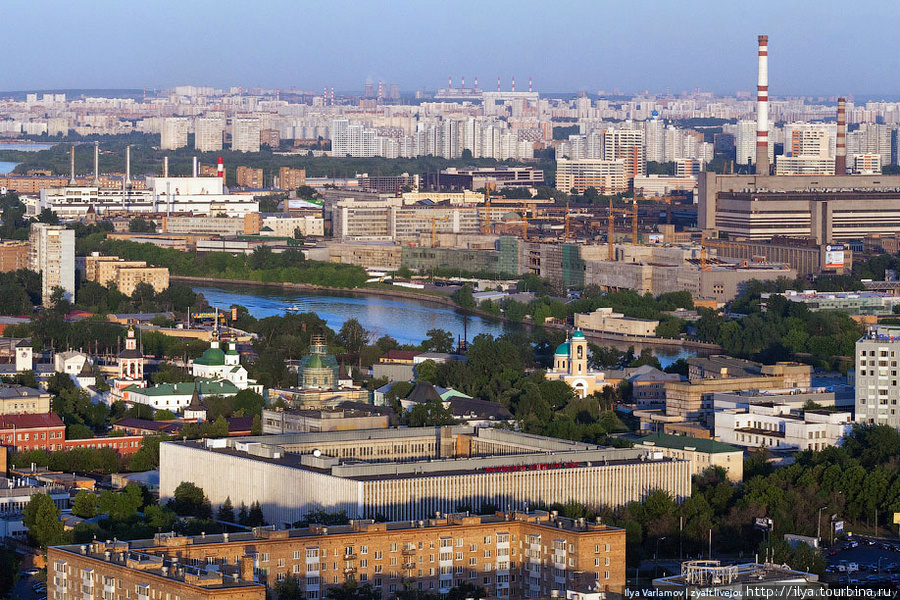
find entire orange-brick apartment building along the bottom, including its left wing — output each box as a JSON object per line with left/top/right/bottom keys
{"left": 48, "top": 511, "right": 625, "bottom": 600}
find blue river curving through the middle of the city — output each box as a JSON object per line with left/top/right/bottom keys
{"left": 193, "top": 285, "right": 696, "bottom": 367}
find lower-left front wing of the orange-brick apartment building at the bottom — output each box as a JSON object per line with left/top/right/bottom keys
{"left": 47, "top": 540, "right": 266, "bottom": 600}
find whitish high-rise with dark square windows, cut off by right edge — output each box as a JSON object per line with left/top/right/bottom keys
{"left": 855, "top": 326, "right": 900, "bottom": 428}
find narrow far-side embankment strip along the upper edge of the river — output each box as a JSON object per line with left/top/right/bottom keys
{"left": 176, "top": 275, "right": 721, "bottom": 352}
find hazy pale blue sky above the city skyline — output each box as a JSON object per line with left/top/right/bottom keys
{"left": 0, "top": 0, "right": 900, "bottom": 97}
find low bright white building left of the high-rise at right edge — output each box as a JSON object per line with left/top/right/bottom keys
{"left": 715, "top": 403, "right": 853, "bottom": 451}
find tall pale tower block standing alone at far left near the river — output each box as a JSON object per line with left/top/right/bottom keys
{"left": 29, "top": 223, "right": 75, "bottom": 306}
